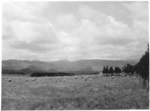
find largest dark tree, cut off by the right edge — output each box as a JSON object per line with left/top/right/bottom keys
{"left": 135, "top": 45, "right": 149, "bottom": 86}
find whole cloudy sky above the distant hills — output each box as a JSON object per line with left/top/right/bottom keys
{"left": 2, "top": 1, "right": 149, "bottom": 61}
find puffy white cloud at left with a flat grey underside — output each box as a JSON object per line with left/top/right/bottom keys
{"left": 3, "top": 21, "right": 57, "bottom": 51}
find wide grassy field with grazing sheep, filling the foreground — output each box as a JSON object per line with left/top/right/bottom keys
{"left": 2, "top": 75, "right": 149, "bottom": 110}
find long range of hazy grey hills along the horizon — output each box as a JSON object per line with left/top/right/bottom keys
{"left": 2, "top": 59, "right": 137, "bottom": 73}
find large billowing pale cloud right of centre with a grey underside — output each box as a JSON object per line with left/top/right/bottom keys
{"left": 72, "top": 9, "right": 132, "bottom": 45}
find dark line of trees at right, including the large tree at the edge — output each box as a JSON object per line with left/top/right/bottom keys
{"left": 102, "top": 45, "right": 149, "bottom": 86}
